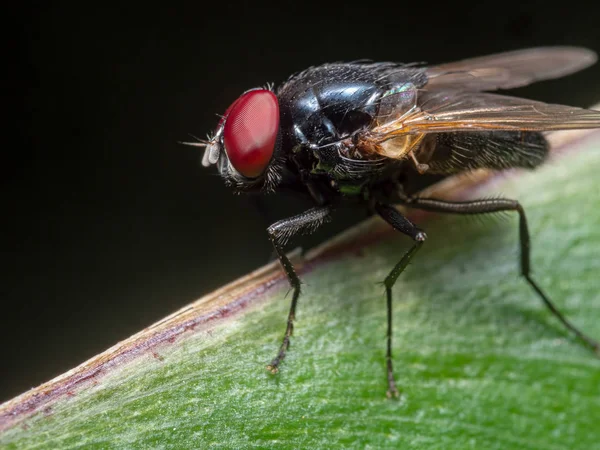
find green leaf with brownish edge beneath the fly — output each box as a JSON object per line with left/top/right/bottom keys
{"left": 0, "top": 128, "right": 600, "bottom": 449}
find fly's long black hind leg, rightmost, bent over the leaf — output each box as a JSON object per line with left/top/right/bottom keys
{"left": 403, "top": 198, "right": 600, "bottom": 356}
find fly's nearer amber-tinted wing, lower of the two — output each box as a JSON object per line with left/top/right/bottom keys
{"left": 372, "top": 91, "right": 600, "bottom": 142}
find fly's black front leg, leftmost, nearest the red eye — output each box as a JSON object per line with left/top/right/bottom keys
{"left": 267, "top": 206, "right": 331, "bottom": 373}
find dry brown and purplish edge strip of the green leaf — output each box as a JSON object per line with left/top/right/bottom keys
{"left": 0, "top": 120, "right": 600, "bottom": 432}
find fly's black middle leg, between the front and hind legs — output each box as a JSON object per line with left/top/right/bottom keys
{"left": 375, "top": 204, "right": 427, "bottom": 398}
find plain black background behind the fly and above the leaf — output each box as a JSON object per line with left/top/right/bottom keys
{"left": 0, "top": 1, "right": 600, "bottom": 401}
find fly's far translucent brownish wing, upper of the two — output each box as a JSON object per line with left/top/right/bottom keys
{"left": 427, "top": 47, "right": 597, "bottom": 91}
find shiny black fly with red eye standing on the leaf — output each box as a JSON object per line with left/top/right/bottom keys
{"left": 183, "top": 47, "right": 600, "bottom": 397}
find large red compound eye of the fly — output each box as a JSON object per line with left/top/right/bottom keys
{"left": 223, "top": 89, "right": 279, "bottom": 178}
